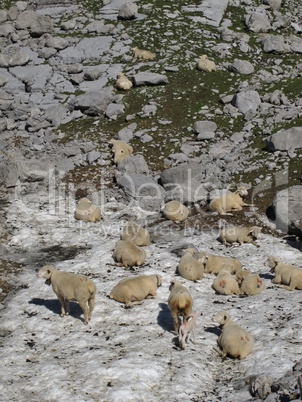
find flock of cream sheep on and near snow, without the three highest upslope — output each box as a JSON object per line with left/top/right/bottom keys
{"left": 37, "top": 140, "right": 302, "bottom": 359}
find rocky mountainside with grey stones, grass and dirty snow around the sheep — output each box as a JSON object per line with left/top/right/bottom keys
{"left": 0, "top": 0, "right": 302, "bottom": 402}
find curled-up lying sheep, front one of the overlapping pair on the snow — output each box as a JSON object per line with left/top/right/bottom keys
{"left": 112, "top": 240, "right": 146, "bottom": 268}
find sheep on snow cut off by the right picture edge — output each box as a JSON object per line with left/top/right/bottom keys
{"left": 268, "top": 256, "right": 302, "bottom": 290}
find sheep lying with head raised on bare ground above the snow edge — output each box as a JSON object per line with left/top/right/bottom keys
{"left": 209, "top": 186, "right": 253, "bottom": 216}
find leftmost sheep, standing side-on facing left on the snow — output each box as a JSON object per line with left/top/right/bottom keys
{"left": 37, "top": 265, "right": 96, "bottom": 325}
